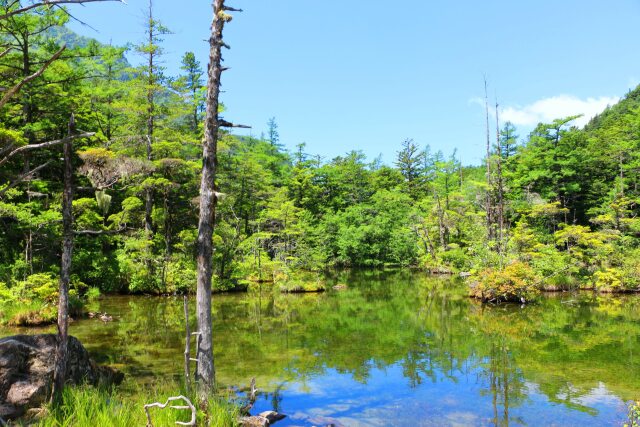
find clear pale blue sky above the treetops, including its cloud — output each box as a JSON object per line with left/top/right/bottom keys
{"left": 65, "top": 0, "right": 640, "bottom": 164}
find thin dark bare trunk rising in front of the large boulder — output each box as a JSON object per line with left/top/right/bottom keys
{"left": 51, "top": 114, "right": 75, "bottom": 401}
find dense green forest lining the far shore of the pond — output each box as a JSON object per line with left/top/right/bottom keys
{"left": 0, "top": 1, "right": 640, "bottom": 427}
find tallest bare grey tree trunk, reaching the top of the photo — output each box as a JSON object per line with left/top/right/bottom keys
{"left": 196, "top": 0, "right": 236, "bottom": 398}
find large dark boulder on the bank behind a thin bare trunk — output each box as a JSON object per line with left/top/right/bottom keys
{"left": 0, "top": 334, "right": 124, "bottom": 419}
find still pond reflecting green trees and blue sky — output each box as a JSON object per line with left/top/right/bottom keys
{"left": 0, "top": 271, "right": 640, "bottom": 426}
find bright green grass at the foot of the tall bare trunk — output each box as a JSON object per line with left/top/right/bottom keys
{"left": 35, "top": 386, "right": 238, "bottom": 427}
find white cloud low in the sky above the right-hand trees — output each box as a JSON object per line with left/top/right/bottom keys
{"left": 500, "top": 95, "right": 620, "bottom": 127}
